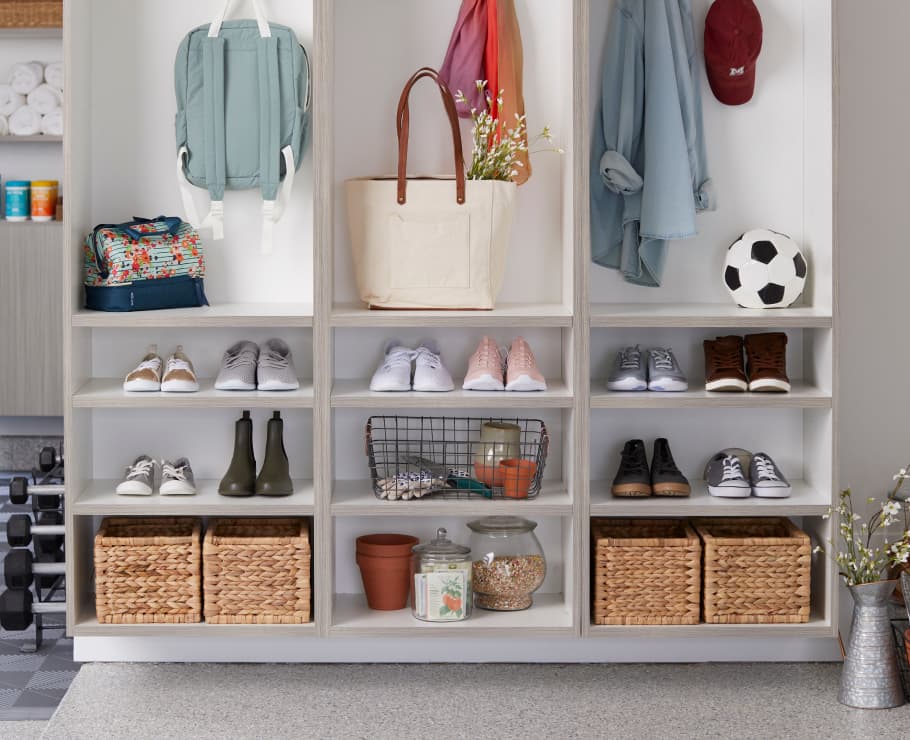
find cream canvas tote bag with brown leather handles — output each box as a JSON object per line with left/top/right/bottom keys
{"left": 345, "top": 67, "right": 516, "bottom": 309}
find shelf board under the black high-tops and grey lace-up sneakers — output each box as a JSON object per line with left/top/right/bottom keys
{"left": 591, "top": 480, "right": 831, "bottom": 517}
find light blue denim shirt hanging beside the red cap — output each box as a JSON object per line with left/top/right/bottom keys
{"left": 591, "top": 0, "right": 715, "bottom": 286}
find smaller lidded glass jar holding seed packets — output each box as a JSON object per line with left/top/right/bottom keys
{"left": 411, "top": 527, "right": 474, "bottom": 622}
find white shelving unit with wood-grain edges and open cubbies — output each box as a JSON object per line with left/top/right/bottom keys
{"left": 64, "top": 0, "right": 837, "bottom": 660}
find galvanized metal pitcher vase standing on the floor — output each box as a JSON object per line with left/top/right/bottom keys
{"left": 837, "top": 580, "right": 904, "bottom": 709}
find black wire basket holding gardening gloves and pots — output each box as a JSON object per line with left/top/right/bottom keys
{"left": 366, "top": 416, "right": 550, "bottom": 501}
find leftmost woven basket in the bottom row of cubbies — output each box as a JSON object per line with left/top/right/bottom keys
{"left": 95, "top": 517, "right": 202, "bottom": 624}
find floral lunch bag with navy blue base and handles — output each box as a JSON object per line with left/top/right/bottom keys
{"left": 84, "top": 216, "right": 208, "bottom": 311}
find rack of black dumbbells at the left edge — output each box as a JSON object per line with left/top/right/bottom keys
{"left": 0, "top": 448, "right": 66, "bottom": 653}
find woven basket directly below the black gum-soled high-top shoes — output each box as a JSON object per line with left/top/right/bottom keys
{"left": 591, "top": 519, "right": 701, "bottom": 624}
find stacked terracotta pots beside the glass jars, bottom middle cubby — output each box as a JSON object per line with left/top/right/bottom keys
{"left": 357, "top": 534, "right": 419, "bottom": 611}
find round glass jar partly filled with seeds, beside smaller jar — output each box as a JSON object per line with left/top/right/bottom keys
{"left": 468, "top": 516, "right": 547, "bottom": 611}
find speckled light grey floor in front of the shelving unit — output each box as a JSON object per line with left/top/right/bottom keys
{"left": 35, "top": 663, "right": 910, "bottom": 740}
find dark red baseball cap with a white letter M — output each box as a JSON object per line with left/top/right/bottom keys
{"left": 705, "top": 0, "right": 762, "bottom": 105}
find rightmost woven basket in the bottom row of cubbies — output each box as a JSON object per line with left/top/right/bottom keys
{"left": 694, "top": 517, "right": 812, "bottom": 624}
